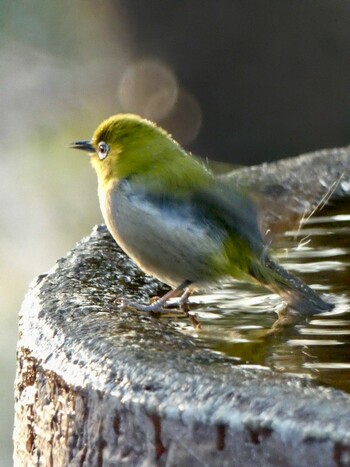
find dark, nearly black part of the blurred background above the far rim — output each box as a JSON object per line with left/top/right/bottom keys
{"left": 122, "top": 0, "right": 350, "bottom": 165}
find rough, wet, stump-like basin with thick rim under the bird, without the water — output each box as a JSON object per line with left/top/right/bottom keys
{"left": 14, "top": 149, "right": 350, "bottom": 467}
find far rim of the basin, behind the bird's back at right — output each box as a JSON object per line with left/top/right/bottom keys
{"left": 227, "top": 146, "right": 350, "bottom": 231}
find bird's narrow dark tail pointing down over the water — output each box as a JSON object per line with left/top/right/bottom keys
{"left": 250, "top": 255, "right": 334, "bottom": 315}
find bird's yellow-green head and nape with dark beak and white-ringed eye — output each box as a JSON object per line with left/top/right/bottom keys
{"left": 71, "top": 114, "right": 209, "bottom": 191}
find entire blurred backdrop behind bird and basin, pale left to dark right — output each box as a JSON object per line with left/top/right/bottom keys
{"left": 0, "top": 0, "right": 350, "bottom": 466}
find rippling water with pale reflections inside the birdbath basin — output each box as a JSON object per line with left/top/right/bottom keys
{"left": 180, "top": 204, "right": 350, "bottom": 392}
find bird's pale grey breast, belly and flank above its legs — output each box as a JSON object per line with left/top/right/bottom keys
{"left": 99, "top": 179, "right": 227, "bottom": 286}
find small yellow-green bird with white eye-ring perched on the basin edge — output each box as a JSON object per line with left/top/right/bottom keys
{"left": 70, "top": 114, "right": 333, "bottom": 314}
